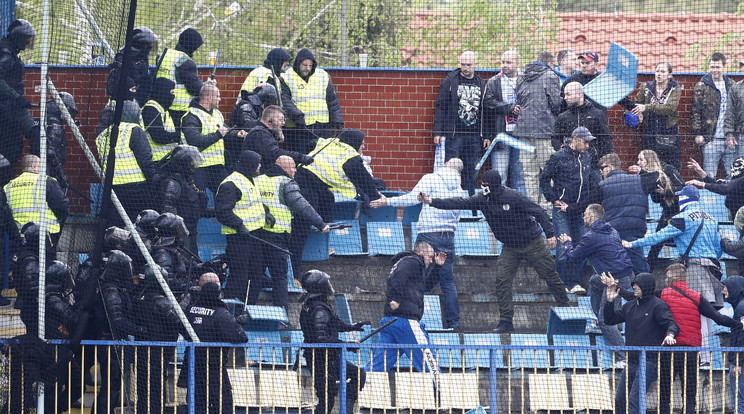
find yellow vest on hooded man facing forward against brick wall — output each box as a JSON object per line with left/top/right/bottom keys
{"left": 282, "top": 68, "right": 331, "bottom": 125}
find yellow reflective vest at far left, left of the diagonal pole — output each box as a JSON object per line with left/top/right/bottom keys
{"left": 5, "top": 172, "right": 60, "bottom": 234}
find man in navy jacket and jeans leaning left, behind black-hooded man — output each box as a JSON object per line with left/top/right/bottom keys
{"left": 558, "top": 204, "right": 633, "bottom": 368}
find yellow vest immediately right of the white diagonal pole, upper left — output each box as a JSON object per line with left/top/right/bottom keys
{"left": 96, "top": 122, "right": 146, "bottom": 185}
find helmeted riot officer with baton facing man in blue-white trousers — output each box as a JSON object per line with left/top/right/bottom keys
{"left": 300, "top": 270, "right": 369, "bottom": 414}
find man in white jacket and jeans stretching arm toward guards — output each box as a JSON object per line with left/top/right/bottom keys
{"left": 370, "top": 158, "right": 463, "bottom": 331}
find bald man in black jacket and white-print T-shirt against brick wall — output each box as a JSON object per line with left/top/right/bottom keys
{"left": 434, "top": 51, "right": 486, "bottom": 195}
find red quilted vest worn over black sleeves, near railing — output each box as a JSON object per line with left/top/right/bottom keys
{"left": 659, "top": 281, "right": 703, "bottom": 346}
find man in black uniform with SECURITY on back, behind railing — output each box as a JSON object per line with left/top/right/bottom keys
{"left": 181, "top": 283, "right": 248, "bottom": 414}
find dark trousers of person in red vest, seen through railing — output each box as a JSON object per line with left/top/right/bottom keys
{"left": 659, "top": 345, "right": 698, "bottom": 414}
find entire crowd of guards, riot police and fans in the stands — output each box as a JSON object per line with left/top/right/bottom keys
{"left": 5, "top": 13, "right": 744, "bottom": 413}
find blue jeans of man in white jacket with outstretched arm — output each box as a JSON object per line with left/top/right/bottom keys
{"left": 416, "top": 232, "right": 460, "bottom": 328}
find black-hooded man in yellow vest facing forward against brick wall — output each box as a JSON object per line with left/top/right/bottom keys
{"left": 281, "top": 49, "right": 344, "bottom": 154}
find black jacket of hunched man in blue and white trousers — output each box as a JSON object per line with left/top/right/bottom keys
{"left": 385, "top": 251, "right": 440, "bottom": 321}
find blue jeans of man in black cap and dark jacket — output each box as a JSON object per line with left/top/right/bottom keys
{"left": 553, "top": 207, "right": 586, "bottom": 289}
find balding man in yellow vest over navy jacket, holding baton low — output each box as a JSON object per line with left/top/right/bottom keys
{"left": 254, "top": 155, "right": 330, "bottom": 308}
